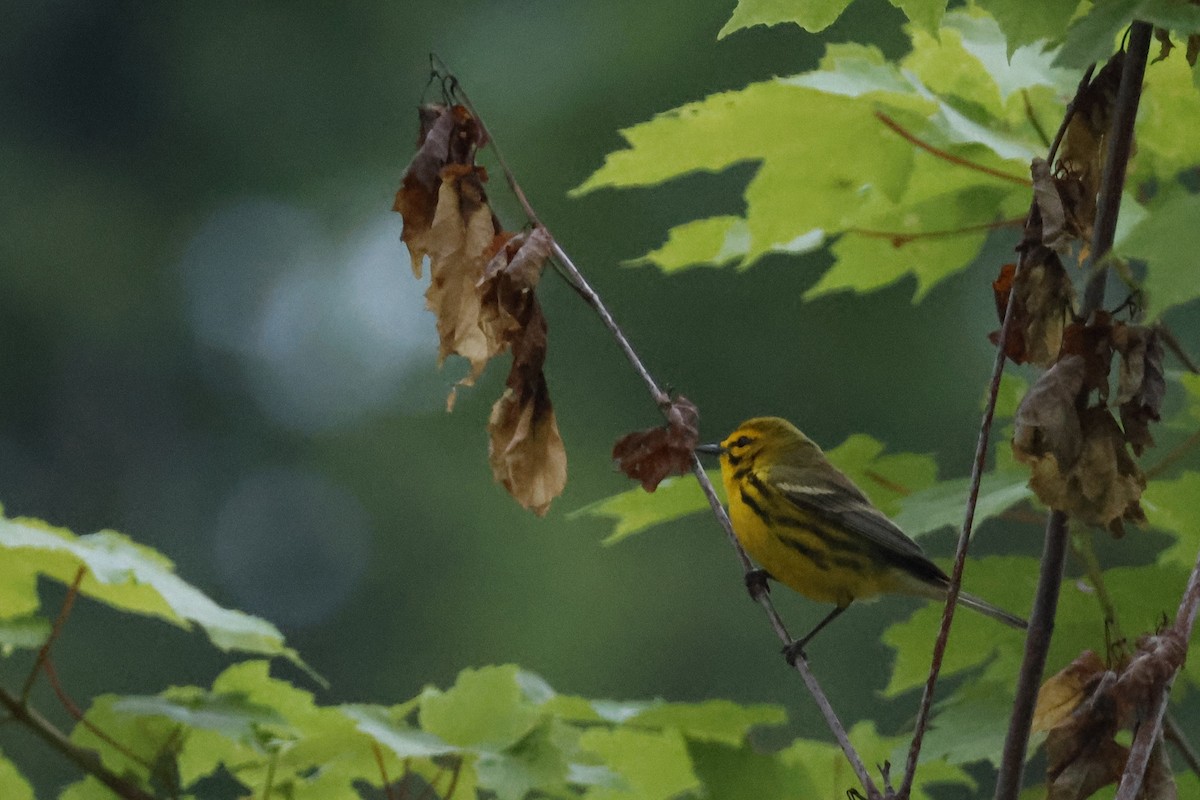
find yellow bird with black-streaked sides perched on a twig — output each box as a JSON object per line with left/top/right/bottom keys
{"left": 696, "top": 416, "right": 1027, "bottom": 660}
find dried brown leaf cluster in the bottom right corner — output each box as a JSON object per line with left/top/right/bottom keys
{"left": 1033, "top": 627, "right": 1187, "bottom": 800}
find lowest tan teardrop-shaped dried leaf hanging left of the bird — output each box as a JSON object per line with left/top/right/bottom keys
{"left": 487, "top": 294, "right": 566, "bottom": 516}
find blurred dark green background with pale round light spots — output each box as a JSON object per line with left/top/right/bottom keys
{"left": 0, "top": 0, "right": 1152, "bottom": 796}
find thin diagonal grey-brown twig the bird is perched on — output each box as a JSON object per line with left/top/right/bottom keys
{"left": 439, "top": 65, "right": 883, "bottom": 800}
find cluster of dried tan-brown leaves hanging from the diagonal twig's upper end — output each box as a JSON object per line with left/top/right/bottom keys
{"left": 394, "top": 106, "right": 566, "bottom": 515}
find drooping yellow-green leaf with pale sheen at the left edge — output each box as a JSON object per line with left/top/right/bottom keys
{"left": 0, "top": 518, "right": 308, "bottom": 669}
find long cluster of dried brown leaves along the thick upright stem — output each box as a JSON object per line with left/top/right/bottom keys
{"left": 992, "top": 53, "right": 1166, "bottom": 535}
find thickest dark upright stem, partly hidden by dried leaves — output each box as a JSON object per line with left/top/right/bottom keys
{"left": 996, "top": 22, "right": 1151, "bottom": 800}
